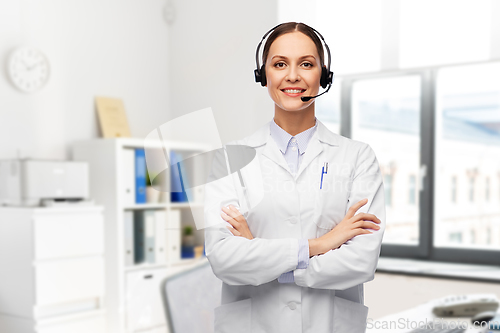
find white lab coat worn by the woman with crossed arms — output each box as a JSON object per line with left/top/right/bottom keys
{"left": 205, "top": 120, "right": 385, "bottom": 333}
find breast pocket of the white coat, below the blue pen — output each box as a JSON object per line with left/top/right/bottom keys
{"left": 314, "top": 173, "right": 350, "bottom": 231}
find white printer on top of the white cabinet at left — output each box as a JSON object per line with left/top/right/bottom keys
{"left": 0, "top": 159, "right": 89, "bottom": 207}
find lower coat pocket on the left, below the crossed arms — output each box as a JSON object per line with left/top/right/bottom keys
{"left": 214, "top": 298, "right": 252, "bottom": 333}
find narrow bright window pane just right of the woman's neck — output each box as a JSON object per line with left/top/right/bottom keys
{"left": 314, "top": 79, "right": 342, "bottom": 134}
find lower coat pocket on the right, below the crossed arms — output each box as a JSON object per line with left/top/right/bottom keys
{"left": 333, "top": 296, "right": 368, "bottom": 333}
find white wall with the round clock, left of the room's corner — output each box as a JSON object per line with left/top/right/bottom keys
{"left": 0, "top": 0, "right": 169, "bottom": 159}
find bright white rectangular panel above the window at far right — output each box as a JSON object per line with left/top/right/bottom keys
{"left": 399, "top": 0, "right": 492, "bottom": 68}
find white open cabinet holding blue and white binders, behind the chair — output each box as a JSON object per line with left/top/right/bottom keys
{"left": 73, "top": 138, "right": 210, "bottom": 333}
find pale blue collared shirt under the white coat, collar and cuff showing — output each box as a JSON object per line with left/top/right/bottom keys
{"left": 271, "top": 118, "right": 318, "bottom": 283}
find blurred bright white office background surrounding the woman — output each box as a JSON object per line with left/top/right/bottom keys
{"left": 0, "top": 0, "right": 500, "bottom": 333}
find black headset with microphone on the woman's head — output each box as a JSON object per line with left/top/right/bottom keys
{"left": 254, "top": 23, "right": 335, "bottom": 102}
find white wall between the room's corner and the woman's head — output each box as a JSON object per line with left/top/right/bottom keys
{"left": 169, "top": 0, "right": 277, "bottom": 143}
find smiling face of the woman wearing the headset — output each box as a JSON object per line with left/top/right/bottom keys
{"left": 266, "top": 31, "right": 321, "bottom": 111}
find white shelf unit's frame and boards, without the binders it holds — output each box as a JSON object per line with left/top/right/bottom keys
{"left": 73, "top": 138, "right": 210, "bottom": 333}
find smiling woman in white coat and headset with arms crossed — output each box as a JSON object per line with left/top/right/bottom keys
{"left": 205, "top": 22, "right": 385, "bottom": 333}
